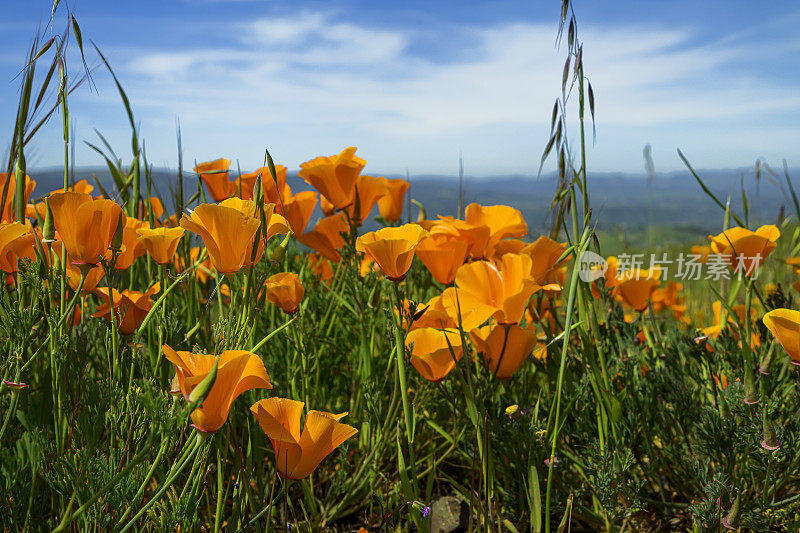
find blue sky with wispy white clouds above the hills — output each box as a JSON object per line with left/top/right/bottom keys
{"left": 0, "top": 0, "right": 800, "bottom": 176}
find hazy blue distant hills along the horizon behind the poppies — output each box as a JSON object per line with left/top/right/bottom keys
{"left": 29, "top": 167, "right": 800, "bottom": 235}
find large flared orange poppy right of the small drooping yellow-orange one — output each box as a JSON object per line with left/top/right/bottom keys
{"left": 181, "top": 198, "right": 268, "bottom": 274}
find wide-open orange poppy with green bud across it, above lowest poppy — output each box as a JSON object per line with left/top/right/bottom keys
{"left": 162, "top": 344, "right": 272, "bottom": 432}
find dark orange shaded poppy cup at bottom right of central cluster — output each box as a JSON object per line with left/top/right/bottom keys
{"left": 469, "top": 324, "right": 536, "bottom": 379}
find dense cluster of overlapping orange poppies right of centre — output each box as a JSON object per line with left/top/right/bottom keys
{"left": 356, "top": 204, "right": 565, "bottom": 382}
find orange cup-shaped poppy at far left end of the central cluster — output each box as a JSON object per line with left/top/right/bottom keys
{"left": 356, "top": 224, "right": 429, "bottom": 281}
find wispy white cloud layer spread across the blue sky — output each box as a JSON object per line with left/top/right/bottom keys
{"left": 61, "top": 11, "right": 800, "bottom": 171}
